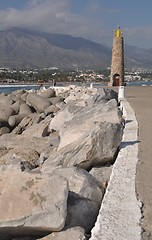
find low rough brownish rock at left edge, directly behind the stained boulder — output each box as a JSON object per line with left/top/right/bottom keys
{"left": 0, "top": 132, "right": 57, "bottom": 165}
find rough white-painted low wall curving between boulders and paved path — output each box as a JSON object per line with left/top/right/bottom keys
{"left": 90, "top": 100, "right": 142, "bottom": 240}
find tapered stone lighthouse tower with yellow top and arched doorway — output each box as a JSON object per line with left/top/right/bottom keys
{"left": 109, "top": 26, "right": 125, "bottom": 86}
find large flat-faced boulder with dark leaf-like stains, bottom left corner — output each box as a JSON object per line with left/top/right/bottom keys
{"left": 0, "top": 167, "right": 69, "bottom": 239}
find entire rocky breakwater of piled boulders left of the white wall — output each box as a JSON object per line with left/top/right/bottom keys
{"left": 0, "top": 86, "right": 123, "bottom": 240}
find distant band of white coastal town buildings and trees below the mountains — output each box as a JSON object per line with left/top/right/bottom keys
{"left": 0, "top": 67, "right": 152, "bottom": 84}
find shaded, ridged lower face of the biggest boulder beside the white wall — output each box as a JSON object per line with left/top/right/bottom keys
{"left": 43, "top": 123, "right": 123, "bottom": 171}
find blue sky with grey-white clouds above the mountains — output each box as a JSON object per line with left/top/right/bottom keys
{"left": 0, "top": 0, "right": 152, "bottom": 48}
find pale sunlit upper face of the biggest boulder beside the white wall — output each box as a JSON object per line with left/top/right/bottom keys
{"left": 49, "top": 100, "right": 122, "bottom": 149}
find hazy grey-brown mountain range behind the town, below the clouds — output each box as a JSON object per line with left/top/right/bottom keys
{"left": 0, "top": 28, "right": 152, "bottom": 69}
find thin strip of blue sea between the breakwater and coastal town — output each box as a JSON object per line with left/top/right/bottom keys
{"left": 0, "top": 81, "right": 152, "bottom": 94}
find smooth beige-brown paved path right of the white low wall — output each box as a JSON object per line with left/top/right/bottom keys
{"left": 125, "top": 86, "right": 152, "bottom": 240}
